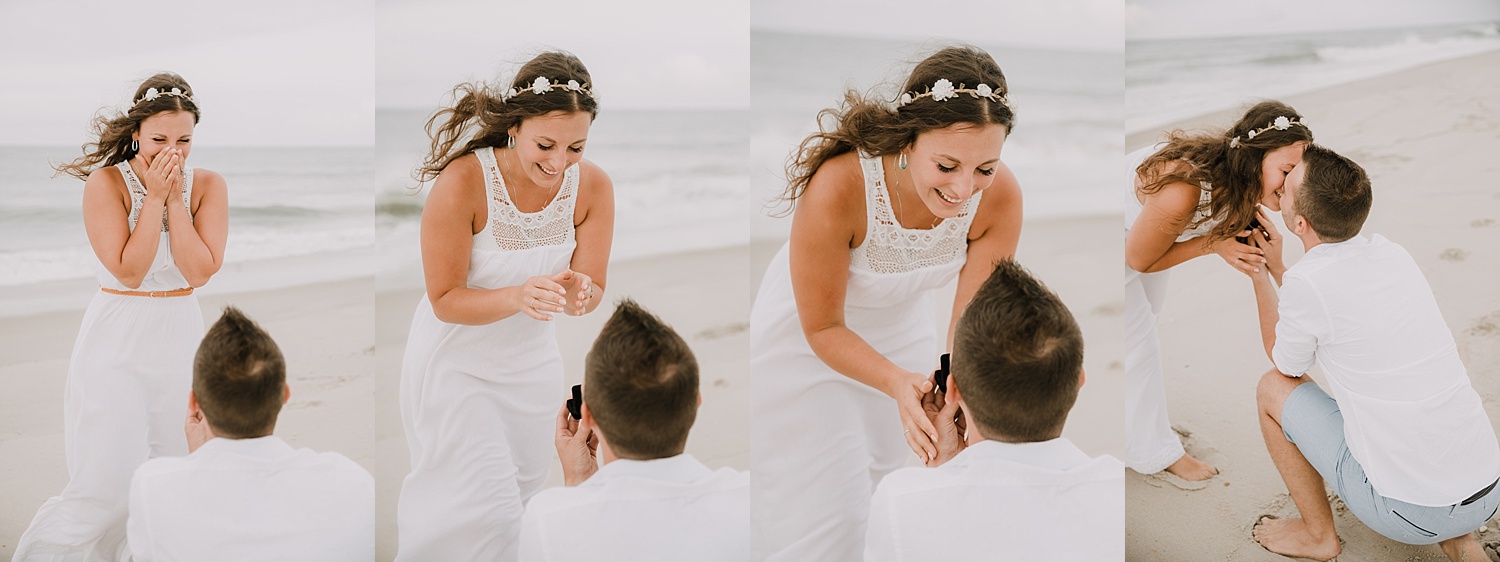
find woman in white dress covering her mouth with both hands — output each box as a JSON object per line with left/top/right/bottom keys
{"left": 15, "top": 73, "right": 230, "bottom": 561}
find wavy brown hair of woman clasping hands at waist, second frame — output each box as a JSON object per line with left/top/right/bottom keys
{"left": 411, "top": 51, "right": 599, "bottom": 184}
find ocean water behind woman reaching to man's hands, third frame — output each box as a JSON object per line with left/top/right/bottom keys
{"left": 747, "top": 30, "right": 1125, "bottom": 240}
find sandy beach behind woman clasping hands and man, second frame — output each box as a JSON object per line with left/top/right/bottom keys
{"left": 372, "top": 246, "right": 759, "bottom": 561}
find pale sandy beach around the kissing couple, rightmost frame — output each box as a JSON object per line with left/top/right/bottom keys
{"left": 1125, "top": 52, "right": 1500, "bottom": 561}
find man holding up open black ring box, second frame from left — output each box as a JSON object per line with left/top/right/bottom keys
{"left": 521, "top": 300, "right": 750, "bottom": 562}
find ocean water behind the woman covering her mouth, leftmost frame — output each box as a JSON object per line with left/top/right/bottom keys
{"left": 0, "top": 145, "right": 374, "bottom": 312}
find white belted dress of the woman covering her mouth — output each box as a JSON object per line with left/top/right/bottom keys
{"left": 15, "top": 162, "right": 203, "bottom": 562}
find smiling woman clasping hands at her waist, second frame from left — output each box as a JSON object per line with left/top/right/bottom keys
{"left": 396, "top": 52, "right": 615, "bottom": 561}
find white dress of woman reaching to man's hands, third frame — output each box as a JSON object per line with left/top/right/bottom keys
{"left": 750, "top": 157, "right": 980, "bottom": 562}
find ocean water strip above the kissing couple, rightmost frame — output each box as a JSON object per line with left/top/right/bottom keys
{"left": 1125, "top": 22, "right": 1500, "bottom": 132}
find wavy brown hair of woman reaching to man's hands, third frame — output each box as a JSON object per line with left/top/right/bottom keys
{"left": 773, "top": 45, "right": 1016, "bottom": 216}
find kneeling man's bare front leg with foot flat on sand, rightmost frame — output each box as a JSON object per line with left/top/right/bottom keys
{"left": 1254, "top": 370, "right": 1340, "bottom": 561}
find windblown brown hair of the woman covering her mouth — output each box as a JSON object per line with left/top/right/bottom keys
{"left": 53, "top": 72, "right": 198, "bottom": 180}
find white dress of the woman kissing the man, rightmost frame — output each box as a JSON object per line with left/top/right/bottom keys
{"left": 1125, "top": 145, "right": 1220, "bottom": 474}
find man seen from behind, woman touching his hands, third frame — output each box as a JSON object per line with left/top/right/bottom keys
{"left": 864, "top": 261, "right": 1125, "bottom": 562}
